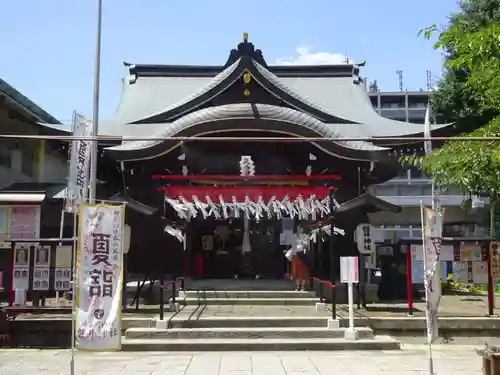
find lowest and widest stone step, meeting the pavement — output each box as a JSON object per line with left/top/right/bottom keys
{"left": 122, "top": 336, "right": 401, "bottom": 352}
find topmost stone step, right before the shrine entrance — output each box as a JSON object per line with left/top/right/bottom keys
{"left": 184, "top": 290, "right": 316, "bottom": 299}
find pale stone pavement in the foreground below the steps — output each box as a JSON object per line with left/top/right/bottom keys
{"left": 0, "top": 344, "right": 482, "bottom": 375}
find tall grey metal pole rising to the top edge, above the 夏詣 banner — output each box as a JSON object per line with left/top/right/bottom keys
{"left": 89, "top": 0, "right": 102, "bottom": 204}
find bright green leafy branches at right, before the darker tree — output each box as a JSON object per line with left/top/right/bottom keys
{"left": 416, "top": 22, "right": 500, "bottom": 201}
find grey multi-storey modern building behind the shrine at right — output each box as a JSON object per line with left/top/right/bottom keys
{"left": 369, "top": 91, "right": 488, "bottom": 240}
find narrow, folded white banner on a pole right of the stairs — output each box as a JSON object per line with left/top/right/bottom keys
{"left": 422, "top": 206, "right": 443, "bottom": 341}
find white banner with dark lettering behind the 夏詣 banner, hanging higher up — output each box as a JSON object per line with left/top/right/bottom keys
{"left": 66, "top": 112, "right": 93, "bottom": 212}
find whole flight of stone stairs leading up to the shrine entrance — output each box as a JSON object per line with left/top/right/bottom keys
{"left": 122, "top": 280, "right": 400, "bottom": 351}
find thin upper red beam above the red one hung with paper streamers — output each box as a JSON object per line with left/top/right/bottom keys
{"left": 151, "top": 174, "right": 342, "bottom": 181}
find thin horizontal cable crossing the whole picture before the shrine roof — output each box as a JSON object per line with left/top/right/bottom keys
{"left": 0, "top": 134, "right": 500, "bottom": 143}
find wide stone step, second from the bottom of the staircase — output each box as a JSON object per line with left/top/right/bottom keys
{"left": 125, "top": 327, "right": 374, "bottom": 340}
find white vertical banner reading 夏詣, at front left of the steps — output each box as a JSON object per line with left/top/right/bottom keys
{"left": 75, "top": 204, "right": 125, "bottom": 351}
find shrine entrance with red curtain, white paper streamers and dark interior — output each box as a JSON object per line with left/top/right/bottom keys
{"left": 160, "top": 181, "right": 336, "bottom": 279}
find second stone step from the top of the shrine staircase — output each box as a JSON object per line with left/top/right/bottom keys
{"left": 182, "top": 297, "right": 319, "bottom": 306}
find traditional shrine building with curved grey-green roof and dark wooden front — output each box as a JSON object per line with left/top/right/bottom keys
{"left": 73, "top": 34, "right": 449, "bottom": 278}
